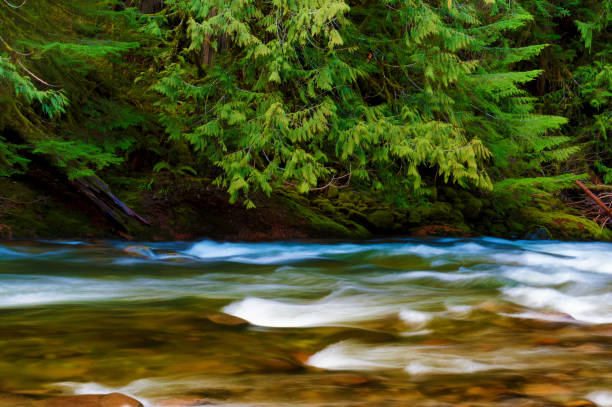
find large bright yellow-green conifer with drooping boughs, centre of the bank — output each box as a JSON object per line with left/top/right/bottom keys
{"left": 143, "top": 0, "right": 577, "bottom": 206}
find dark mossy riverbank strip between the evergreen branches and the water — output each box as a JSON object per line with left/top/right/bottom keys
{"left": 0, "top": 174, "right": 612, "bottom": 241}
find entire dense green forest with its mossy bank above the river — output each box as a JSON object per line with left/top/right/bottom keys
{"left": 0, "top": 0, "right": 612, "bottom": 239}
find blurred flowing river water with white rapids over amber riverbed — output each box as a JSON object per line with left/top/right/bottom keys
{"left": 0, "top": 238, "right": 612, "bottom": 407}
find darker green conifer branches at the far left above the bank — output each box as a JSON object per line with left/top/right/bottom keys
{"left": 0, "top": 0, "right": 144, "bottom": 178}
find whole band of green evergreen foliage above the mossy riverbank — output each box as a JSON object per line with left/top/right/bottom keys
{"left": 0, "top": 0, "right": 612, "bottom": 233}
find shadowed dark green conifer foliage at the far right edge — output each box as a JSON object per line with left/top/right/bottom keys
{"left": 521, "top": 0, "right": 612, "bottom": 183}
